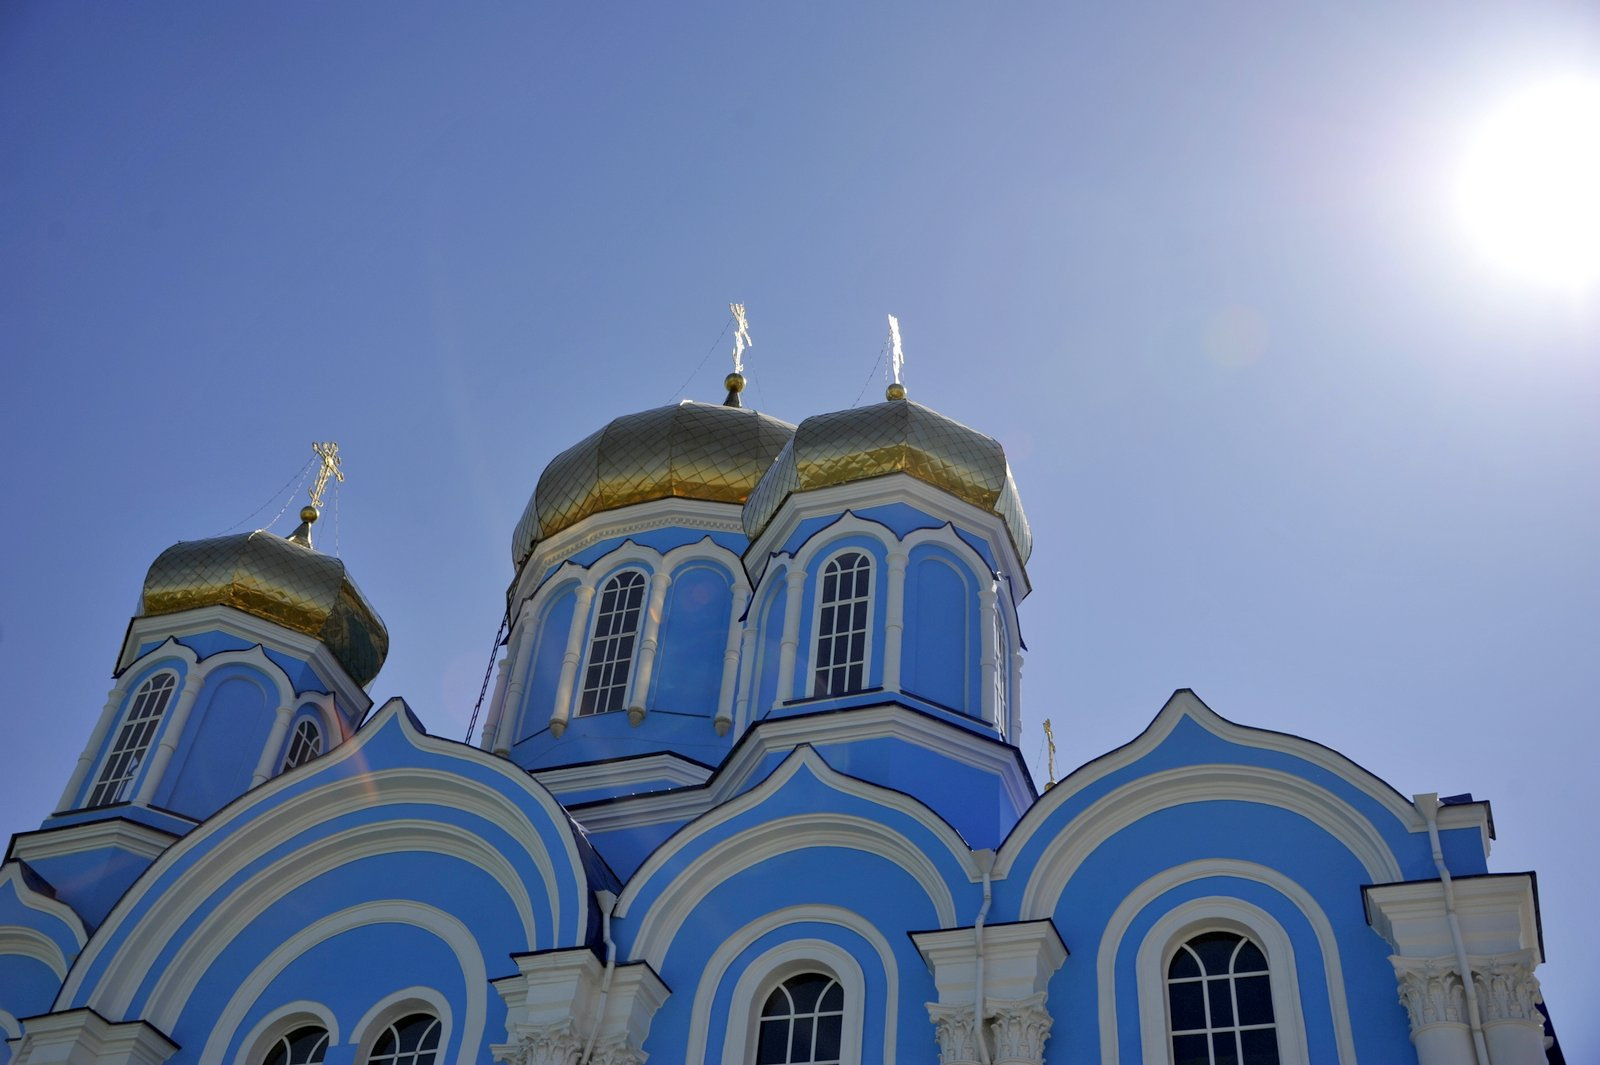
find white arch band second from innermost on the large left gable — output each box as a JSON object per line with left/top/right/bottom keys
{"left": 141, "top": 809, "right": 536, "bottom": 1031}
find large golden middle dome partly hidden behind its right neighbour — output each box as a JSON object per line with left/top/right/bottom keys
{"left": 512, "top": 398, "right": 795, "bottom": 566}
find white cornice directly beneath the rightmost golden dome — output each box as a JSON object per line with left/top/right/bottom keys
{"left": 744, "top": 473, "right": 1030, "bottom": 600}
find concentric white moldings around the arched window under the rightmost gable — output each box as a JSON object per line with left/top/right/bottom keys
{"left": 1094, "top": 859, "right": 1357, "bottom": 1065}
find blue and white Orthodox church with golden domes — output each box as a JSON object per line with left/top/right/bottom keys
{"left": 0, "top": 361, "right": 1560, "bottom": 1065}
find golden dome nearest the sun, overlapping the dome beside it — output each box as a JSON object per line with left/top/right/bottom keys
{"left": 744, "top": 396, "right": 1034, "bottom": 561}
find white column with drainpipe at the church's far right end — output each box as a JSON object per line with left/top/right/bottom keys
{"left": 1365, "top": 873, "right": 1544, "bottom": 1065}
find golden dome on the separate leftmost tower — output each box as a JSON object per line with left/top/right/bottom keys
{"left": 141, "top": 527, "right": 389, "bottom": 688}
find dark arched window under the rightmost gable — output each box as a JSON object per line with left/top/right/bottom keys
{"left": 1166, "top": 931, "right": 1278, "bottom": 1065}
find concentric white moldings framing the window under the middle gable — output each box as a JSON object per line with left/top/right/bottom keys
{"left": 685, "top": 905, "right": 899, "bottom": 1065}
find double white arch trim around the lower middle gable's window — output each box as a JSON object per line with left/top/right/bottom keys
{"left": 697, "top": 907, "right": 876, "bottom": 1065}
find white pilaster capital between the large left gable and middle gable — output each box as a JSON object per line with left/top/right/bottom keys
{"left": 490, "top": 948, "right": 669, "bottom": 1065}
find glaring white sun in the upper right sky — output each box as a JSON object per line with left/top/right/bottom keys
{"left": 1458, "top": 77, "right": 1600, "bottom": 289}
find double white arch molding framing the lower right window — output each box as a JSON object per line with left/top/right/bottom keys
{"left": 1094, "top": 859, "right": 1357, "bottom": 1065}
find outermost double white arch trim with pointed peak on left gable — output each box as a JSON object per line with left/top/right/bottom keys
{"left": 59, "top": 699, "right": 589, "bottom": 1012}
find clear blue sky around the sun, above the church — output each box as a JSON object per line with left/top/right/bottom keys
{"left": 0, "top": 0, "right": 1600, "bottom": 1060}
